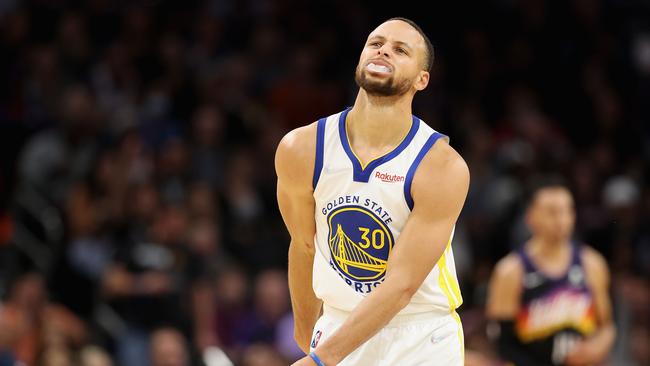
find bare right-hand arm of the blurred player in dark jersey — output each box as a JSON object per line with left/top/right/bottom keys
{"left": 566, "top": 247, "right": 616, "bottom": 365}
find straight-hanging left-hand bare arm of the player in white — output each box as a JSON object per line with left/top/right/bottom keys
{"left": 275, "top": 123, "right": 322, "bottom": 353}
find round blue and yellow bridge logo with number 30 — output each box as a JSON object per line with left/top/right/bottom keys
{"left": 327, "top": 206, "right": 394, "bottom": 293}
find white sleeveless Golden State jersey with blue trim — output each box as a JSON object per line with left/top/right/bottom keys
{"left": 313, "top": 108, "right": 463, "bottom": 314}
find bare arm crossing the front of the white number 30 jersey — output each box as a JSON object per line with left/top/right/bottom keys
{"left": 306, "top": 141, "right": 469, "bottom": 365}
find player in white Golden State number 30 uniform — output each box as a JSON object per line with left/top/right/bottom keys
{"left": 276, "top": 18, "right": 469, "bottom": 366}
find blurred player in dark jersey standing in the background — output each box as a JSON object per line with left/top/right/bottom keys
{"left": 487, "top": 184, "right": 615, "bottom": 366}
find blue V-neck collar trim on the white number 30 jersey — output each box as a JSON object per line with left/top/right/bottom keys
{"left": 339, "top": 108, "right": 420, "bottom": 183}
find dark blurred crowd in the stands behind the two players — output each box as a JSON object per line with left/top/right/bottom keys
{"left": 0, "top": 0, "right": 650, "bottom": 366}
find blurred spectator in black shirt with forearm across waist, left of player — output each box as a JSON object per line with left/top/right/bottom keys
{"left": 103, "top": 206, "right": 211, "bottom": 366}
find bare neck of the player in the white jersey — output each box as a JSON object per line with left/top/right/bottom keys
{"left": 347, "top": 89, "right": 413, "bottom": 146}
